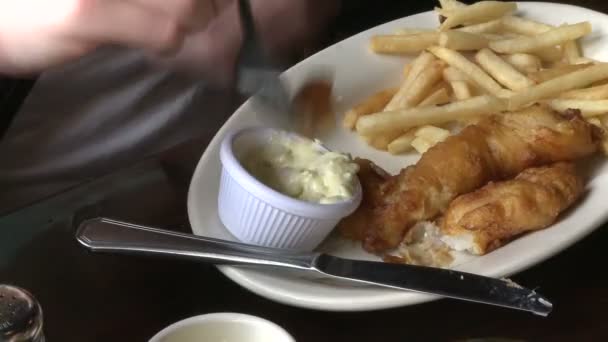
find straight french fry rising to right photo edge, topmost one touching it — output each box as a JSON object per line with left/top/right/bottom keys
{"left": 508, "top": 64, "right": 608, "bottom": 110}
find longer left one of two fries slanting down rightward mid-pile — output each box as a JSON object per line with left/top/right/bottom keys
{"left": 428, "top": 46, "right": 505, "bottom": 96}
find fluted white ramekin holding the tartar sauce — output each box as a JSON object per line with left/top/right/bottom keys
{"left": 218, "top": 128, "right": 361, "bottom": 251}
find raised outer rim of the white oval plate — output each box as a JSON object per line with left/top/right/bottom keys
{"left": 187, "top": 1, "right": 608, "bottom": 312}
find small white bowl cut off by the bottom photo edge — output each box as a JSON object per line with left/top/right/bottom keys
{"left": 149, "top": 313, "right": 295, "bottom": 342}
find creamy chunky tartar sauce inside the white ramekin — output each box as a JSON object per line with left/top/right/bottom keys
{"left": 243, "top": 133, "right": 359, "bottom": 204}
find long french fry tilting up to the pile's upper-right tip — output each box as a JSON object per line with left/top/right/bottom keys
{"left": 490, "top": 22, "right": 591, "bottom": 53}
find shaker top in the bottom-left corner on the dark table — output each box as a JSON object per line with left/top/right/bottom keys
{"left": 0, "top": 284, "right": 44, "bottom": 342}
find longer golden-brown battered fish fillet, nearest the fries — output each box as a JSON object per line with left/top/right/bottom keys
{"left": 339, "top": 106, "right": 599, "bottom": 253}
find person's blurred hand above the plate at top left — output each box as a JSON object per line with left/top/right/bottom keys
{"left": 0, "top": 0, "right": 339, "bottom": 84}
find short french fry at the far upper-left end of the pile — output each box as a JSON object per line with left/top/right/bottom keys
{"left": 370, "top": 32, "right": 439, "bottom": 54}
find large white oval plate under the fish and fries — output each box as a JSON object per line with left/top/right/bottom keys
{"left": 188, "top": 2, "right": 608, "bottom": 311}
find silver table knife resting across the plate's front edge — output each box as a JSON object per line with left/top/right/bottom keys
{"left": 76, "top": 218, "right": 552, "bottom": 316}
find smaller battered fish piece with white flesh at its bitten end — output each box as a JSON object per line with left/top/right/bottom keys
{"left": 441, "top": 163, "right": 584, "bottom": 255}
